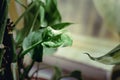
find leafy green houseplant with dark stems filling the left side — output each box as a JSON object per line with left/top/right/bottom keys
{"left": 0, "top": 0, "right": 72, "bottom": 80}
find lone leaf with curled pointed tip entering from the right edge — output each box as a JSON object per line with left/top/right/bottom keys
{"left": 86, "top": 45, "right": 120, "bottom": 65}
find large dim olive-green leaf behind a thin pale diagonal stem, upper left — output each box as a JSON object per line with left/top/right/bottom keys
{"left": 16, "top": 1, "right": 44, "bottom": 44}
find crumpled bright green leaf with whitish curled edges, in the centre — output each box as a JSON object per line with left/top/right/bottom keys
{"left": 42, "top": 27, "right": 72, "bottom": 48}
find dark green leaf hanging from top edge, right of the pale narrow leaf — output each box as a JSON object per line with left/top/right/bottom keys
{"left": 45, "top": 0, "right": 61, "bottom": 26}
